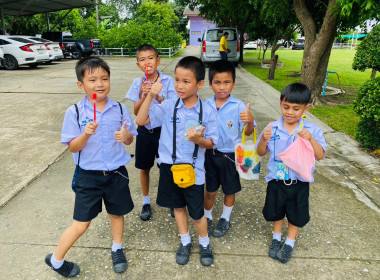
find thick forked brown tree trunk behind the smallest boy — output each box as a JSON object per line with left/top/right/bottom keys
{"left": 294, "top": 0, "right": 337, "bottom": 105}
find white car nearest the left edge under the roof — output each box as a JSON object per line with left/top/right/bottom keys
{"left": 0, "top": 35, "right": 50, "bottom": 70}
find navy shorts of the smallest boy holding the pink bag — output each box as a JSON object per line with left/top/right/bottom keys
{"left": 263, "top": 180, "right": 310, "bottom": 227}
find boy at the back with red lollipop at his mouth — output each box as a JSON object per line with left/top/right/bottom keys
{"left": 126, "top": 45, "right": 177, "bottom": 221}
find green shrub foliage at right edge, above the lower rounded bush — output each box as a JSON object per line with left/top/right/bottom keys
{"left": 352, "top": 24, "right": 380, "bottom": 78}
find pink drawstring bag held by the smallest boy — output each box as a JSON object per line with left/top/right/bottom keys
{"left": 277, "top": 136, "right": 315, "bottom": 182}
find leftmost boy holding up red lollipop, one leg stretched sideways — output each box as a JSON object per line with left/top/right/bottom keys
{"left": 45, "top": 57, "right": 137, "bottom": 277}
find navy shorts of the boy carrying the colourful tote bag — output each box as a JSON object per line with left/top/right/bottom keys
{"left": 205, "top": 149, "right": 241, "bottom": 195}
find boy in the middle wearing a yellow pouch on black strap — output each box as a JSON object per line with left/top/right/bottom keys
{"left": 136, "top": 56, "right": 218, "bottom": 266}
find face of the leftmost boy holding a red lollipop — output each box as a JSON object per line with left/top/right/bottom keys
{"left": 77, "top": 67, "right": 111, "bottom": 101}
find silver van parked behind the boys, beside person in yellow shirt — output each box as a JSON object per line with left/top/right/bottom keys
{"left": 198, "top": 27, "right": 240, "bottom": 66}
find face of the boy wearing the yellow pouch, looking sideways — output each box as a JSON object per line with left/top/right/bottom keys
{"left": 174, "top": 67, "right": 204, "bottom": 101}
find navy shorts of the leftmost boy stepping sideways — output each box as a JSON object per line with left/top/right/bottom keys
{"left": 74, "top": 166, "right": 134, "bottom": 222}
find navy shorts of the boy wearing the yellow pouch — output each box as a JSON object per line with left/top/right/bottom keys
{"left": 157, "top": 163, "right": 204, "bottom": 220}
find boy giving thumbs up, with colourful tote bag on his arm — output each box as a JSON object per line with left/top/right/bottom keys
{"left": 204, "top": 60, "right": 254, "bottom": 237}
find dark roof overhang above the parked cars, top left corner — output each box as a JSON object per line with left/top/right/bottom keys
{"left": 0, "top": 0, "right": 96, "bottom": 16}
